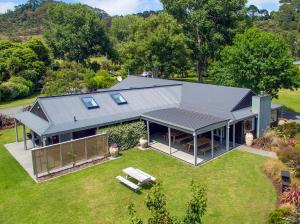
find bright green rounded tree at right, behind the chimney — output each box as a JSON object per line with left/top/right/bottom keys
{"left": 209, "top": 28, "right": 300, "bottom": 97}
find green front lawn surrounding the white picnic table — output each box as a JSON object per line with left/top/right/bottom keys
{"left": 0, "top": 129, "right": 276, "bottom": 224}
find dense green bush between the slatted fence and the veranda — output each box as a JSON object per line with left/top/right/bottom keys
{"left": 100, "top": 121, "right": 146, "bottom": 150}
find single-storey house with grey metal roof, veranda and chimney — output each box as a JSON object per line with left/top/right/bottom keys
{"left": 15, "top": 76, "right": 282, "bottom": 165}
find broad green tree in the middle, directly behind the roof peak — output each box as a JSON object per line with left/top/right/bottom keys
{"left": 118, "top": 13, "right": 191, "bottom": 78}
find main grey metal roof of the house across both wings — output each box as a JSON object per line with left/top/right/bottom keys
{"left": 12, "top": 76, "right": 278, "bottom": 135}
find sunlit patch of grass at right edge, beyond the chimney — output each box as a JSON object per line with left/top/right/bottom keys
{"left": 273, "top": 89, "right": 300, "bottom": 113}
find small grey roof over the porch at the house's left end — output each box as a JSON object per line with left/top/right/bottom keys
{"left": 15, "top": 111, "right": 49, "bottom": 135}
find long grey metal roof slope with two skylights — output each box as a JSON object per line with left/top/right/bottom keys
{"left": 38, "top": 86, "right": 181, "bottom": 134}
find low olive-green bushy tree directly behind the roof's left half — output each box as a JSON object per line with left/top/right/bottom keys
{"left": 42, "top": 62, "right": 93, "bottom": 95}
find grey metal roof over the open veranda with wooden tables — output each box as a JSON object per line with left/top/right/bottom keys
{"left": 142, "top": 108, "right": 228, "bottom": 131}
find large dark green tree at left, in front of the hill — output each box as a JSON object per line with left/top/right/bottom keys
{"left": 45, "top": 3, "right": 112, "bottom": 62}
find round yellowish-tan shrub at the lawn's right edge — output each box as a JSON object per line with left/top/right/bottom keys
{"left": 263, "top": 159, "right": 287, "bottom": 182}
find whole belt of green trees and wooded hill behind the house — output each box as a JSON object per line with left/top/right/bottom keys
{"left": 0, "top": 0, "right": 300, "bottom": 102}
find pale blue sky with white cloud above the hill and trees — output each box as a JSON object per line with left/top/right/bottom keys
{"left": 0, "top": 0, "right": 279, "bottom": 15}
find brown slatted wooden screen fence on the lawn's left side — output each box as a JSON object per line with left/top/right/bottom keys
{"left": 32, "top": 134, "right": 108, "bottom": 176}
